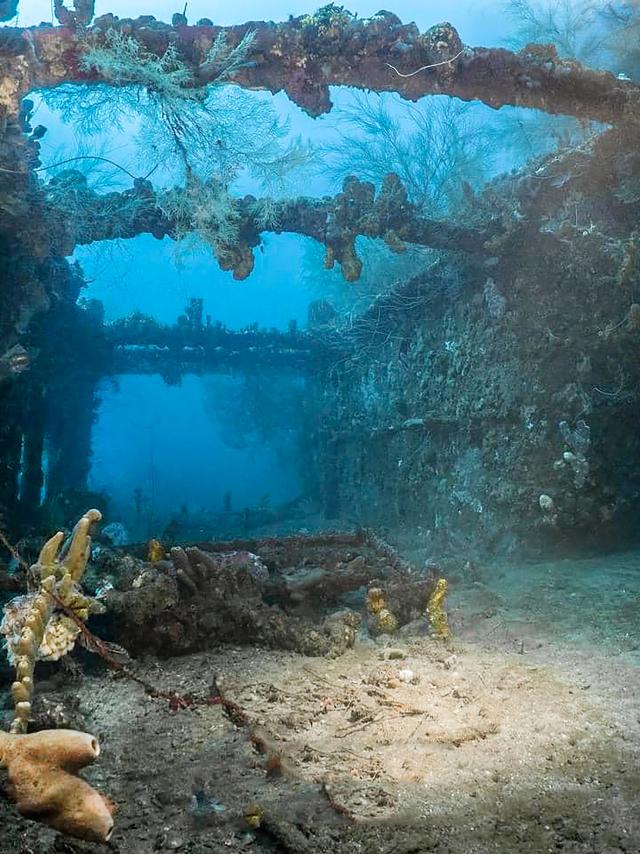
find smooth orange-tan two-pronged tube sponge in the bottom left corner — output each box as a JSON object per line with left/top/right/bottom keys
{"left": 0, "top": 729, "right": 114, "bottom": 842}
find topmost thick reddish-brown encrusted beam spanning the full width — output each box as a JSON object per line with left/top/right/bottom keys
{"left": 0, "top": 6, "right": 640, "bottom": 123}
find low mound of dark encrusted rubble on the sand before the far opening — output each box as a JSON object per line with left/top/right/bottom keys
{"left": 105, "top": 534, "right": 436, "bottom": 656}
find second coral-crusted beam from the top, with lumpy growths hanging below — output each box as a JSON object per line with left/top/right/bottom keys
{"left": 48, "top": 172, "right": 492, "bottom": 281}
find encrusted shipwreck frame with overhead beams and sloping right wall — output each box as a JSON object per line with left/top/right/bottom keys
{"left": 0, "top": 0, "right": 640, "bottom": 551}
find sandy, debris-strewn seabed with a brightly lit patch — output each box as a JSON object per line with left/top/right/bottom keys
{"left": 0, "top": 555, "right": 640, "bottom": 854}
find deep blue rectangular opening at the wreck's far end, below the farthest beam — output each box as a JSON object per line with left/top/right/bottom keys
{"left": 88, "top": 369, "right": 304, "bottom": 542}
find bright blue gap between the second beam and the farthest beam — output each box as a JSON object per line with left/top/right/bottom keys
{"left": 70, "top": 234, "right": 328, "bottom": 333}
